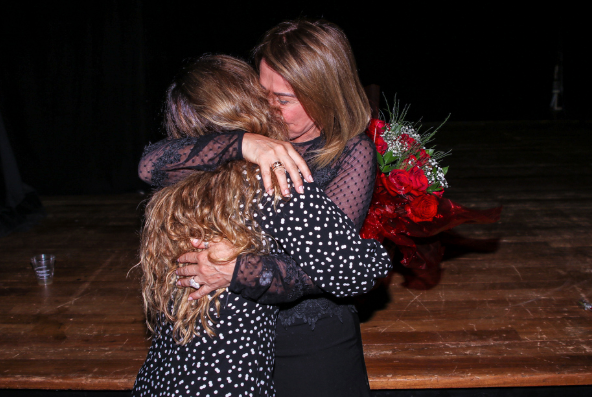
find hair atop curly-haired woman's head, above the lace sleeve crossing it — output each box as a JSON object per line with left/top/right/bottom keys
{"left": 164, "top": 55, "right": 287, "bottom": 140}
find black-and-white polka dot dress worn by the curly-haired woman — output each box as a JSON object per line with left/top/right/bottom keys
{"left": 133, "top": 178, "right": 390, "bottom": 396}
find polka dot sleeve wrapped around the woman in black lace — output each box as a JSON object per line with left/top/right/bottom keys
{"left": 259, "top": 183, "right": 391, "bottom": 297}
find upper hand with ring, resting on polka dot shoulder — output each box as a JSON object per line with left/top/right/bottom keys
{"left": 242, "top": 133, "right": 313, "bottom": 196}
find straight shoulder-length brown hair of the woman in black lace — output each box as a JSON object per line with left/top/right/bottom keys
{"left": 253, "top": 19, "right": 371, "bottom": 166}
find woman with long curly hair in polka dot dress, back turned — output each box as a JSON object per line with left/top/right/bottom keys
{"left": 133, "top": 56, "right": 390, "bottom": 396}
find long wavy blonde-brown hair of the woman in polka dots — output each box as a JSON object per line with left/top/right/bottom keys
{"left": 140, "top": 55, "right": 287, "bottom": 344}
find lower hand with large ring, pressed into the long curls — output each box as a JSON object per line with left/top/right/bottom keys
{"left": 177, "top": 240, "right": 236, "bottom": 300}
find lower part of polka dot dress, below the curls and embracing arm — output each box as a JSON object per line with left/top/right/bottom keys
{"left": 133, "top": 291, "right": 277, "bottom": 397}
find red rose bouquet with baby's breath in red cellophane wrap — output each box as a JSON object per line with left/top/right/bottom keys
{"left": 360, "top": 103, "right": 501, "bottom": 289}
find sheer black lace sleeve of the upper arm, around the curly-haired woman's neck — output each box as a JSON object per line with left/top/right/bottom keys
{"left": 138, "top": 131, "right": 244, "bottom": 187}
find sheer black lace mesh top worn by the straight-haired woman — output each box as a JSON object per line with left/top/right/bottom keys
{"left": 139, "top": 131, "right": 386, "bottom": 327}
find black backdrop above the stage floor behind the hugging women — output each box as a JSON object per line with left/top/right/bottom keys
{"left": 0, "top": 0, "right": 591, "bottom": 194}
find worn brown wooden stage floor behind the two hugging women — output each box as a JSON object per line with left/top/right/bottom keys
{"left": 0, "top": 123, "right": 592, "bottom": 390}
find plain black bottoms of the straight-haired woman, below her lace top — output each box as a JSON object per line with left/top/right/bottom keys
{"left": 274, "top": 310, "right": 370, "bottom": 397}
